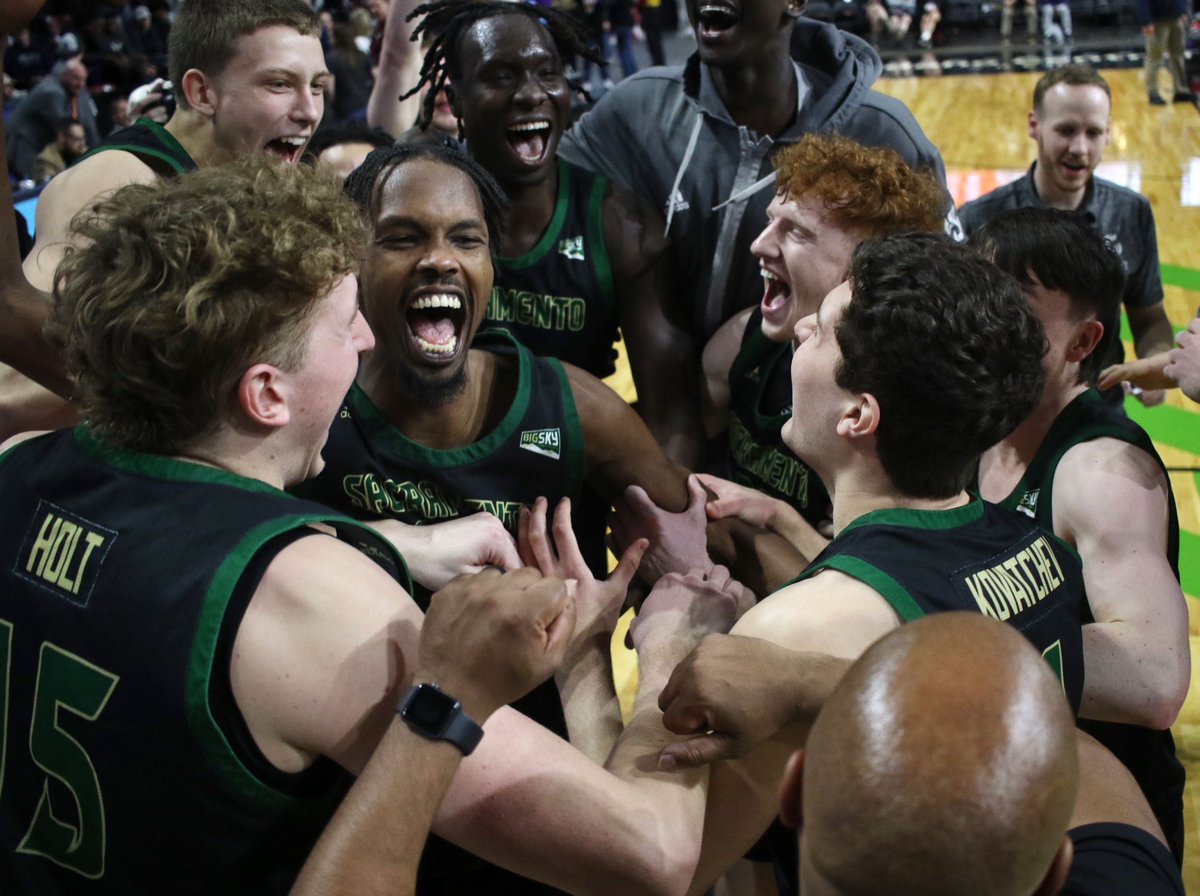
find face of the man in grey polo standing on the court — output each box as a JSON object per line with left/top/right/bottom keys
{"left": 1030, "top": 84, "right": 1111, "bottom": 208}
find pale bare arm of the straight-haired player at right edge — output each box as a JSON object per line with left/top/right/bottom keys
{"left": 1054, "top": 439, "right": 1192, "bottom": 728}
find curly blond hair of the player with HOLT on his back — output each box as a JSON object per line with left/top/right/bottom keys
{"left": 49, "top": 157, "right": 367, "bottom": 453}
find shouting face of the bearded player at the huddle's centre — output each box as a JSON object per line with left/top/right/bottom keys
{"left": 361, "top": 158, "right": 493, "bottom": 403}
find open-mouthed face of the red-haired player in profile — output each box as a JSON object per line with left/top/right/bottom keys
{"left": 750, "top": 196, "right": 863, "bottom": 342}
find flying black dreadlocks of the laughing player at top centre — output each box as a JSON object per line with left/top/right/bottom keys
{"left": 400, "top": 0, "right": 601, "bottom": 128}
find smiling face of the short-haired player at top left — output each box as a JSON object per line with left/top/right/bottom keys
{"left": 202, "top": 25, "right": 330, "bottom": 164}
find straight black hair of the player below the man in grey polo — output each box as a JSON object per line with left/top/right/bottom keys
{"left": 968, "top": 209, "right": 1126, "bottom": 386}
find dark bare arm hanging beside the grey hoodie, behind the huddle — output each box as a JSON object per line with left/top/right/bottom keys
{"left": 604, "top": 188, "right": 703, "bottom": 469}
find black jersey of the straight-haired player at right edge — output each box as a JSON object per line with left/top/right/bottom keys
{"left": 1001, "top": 389, "right": 1187, "bottom": 861}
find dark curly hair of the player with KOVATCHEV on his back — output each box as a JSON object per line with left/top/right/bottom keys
{"left": 835, "top": 233, "right": 1045, "bottom": 499}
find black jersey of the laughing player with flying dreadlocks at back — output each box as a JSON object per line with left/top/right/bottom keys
{"left": 484, "top": 160, "right": 617, "bottom": 377}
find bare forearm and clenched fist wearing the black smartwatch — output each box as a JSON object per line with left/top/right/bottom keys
{"left": 292, "top": 572, "right": 574, "bottom": 896}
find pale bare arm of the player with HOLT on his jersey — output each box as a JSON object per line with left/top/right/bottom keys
{"left": 232, "top": 536, "right": 704, "bottom": 894}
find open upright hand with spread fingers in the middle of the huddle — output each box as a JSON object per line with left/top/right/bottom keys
{"left": 517, "top": 498, "right": 647, "bottom": 636}
